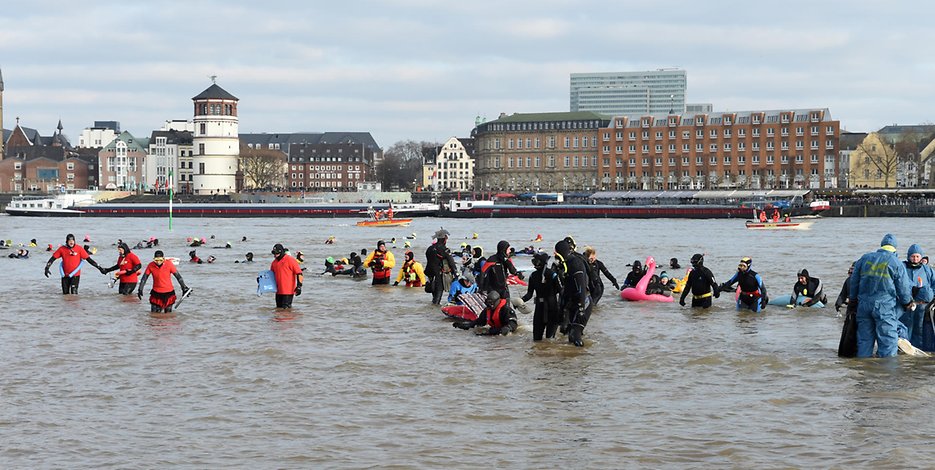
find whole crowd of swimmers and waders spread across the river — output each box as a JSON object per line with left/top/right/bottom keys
{"left": 33, "top": 229, "right": 935, "bottom": 357}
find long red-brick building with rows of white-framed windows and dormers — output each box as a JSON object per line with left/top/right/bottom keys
{"left": 597, "top": 108, "right": 840, "bottom": 190}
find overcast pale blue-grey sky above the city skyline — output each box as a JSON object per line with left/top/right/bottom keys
{"left": 0, "top": 0, "right": 935, "bottom": 148}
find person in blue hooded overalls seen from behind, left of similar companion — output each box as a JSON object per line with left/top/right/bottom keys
{"left": 849, "top": 233, "right": 914, "bottom": 357}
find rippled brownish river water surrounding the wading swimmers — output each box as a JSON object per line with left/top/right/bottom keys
{"left": 0, "top": 216, "right": 935, "bottom": 468}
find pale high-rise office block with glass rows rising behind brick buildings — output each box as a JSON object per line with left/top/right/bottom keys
{"left": 570, "top": 69, "right": 688, "bottom": 117}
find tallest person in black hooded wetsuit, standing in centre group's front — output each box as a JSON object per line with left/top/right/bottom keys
{"left": 555, "top": 240, "right": 591, "bottom": 347}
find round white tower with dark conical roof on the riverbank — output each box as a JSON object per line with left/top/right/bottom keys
{"left": 191, "top": 84, "right": 240, "bottom": 194}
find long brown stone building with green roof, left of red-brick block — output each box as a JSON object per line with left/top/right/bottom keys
{"left": 471, "top": 111, "right": 610, "bottom": 192}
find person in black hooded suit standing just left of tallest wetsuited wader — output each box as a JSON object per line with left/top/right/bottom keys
{"left": 523, "top": 252, "right": 562, "bottom": 341}
